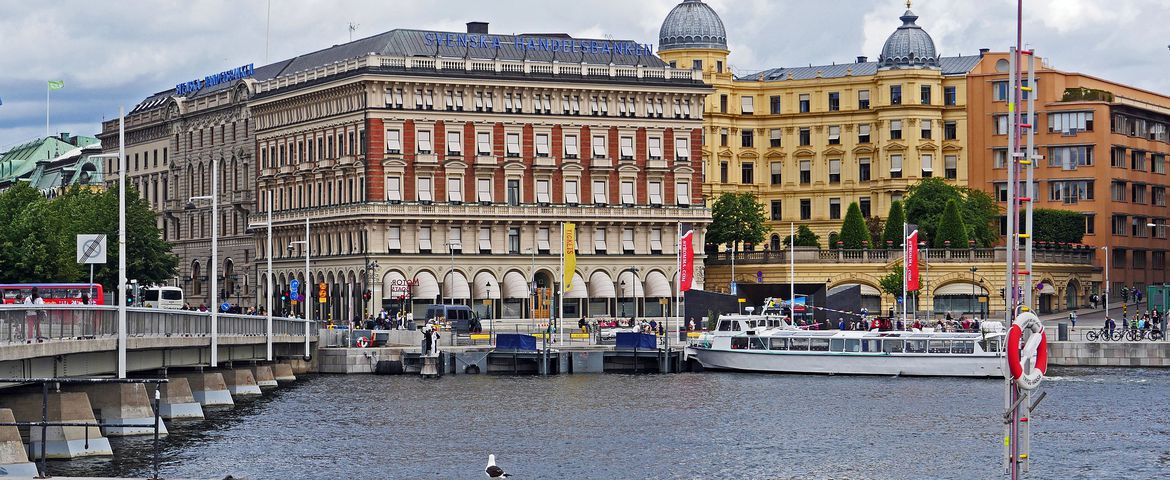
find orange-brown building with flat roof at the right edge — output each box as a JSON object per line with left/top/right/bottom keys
{"left": 966, "top": 53, "right": 1170, "bottom": 308}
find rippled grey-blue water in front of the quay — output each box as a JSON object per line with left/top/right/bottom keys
{"left": 50, "top": 369, "right": 1170, "bottom": 479}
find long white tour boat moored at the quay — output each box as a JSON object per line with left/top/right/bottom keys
{"left": 687, "top": 315, "right": 1006, "bottom": 378}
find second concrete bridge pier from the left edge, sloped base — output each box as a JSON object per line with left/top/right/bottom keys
{"left": 8, "top": 392, "right": 113, "bottom": 459}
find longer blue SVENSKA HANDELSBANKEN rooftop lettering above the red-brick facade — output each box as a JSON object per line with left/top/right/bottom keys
{"left": 422, "top": 32, "right": 654, "bottom": 56}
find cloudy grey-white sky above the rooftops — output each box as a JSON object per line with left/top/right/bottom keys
{"left": 0, "top": 0, "right": 1170, "bottom": 152}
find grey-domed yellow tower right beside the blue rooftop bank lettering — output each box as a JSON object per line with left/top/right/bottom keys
{"left": 659, "top": 0, "right": 729, "bottom": 74}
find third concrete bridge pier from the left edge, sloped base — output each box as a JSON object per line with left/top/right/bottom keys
{"left": 69, "top": 383, "right": 166, "bottom": 437}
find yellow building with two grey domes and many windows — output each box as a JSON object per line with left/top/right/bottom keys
{"left": 659, "top": 0, "right": 979, "bottom": 249}
